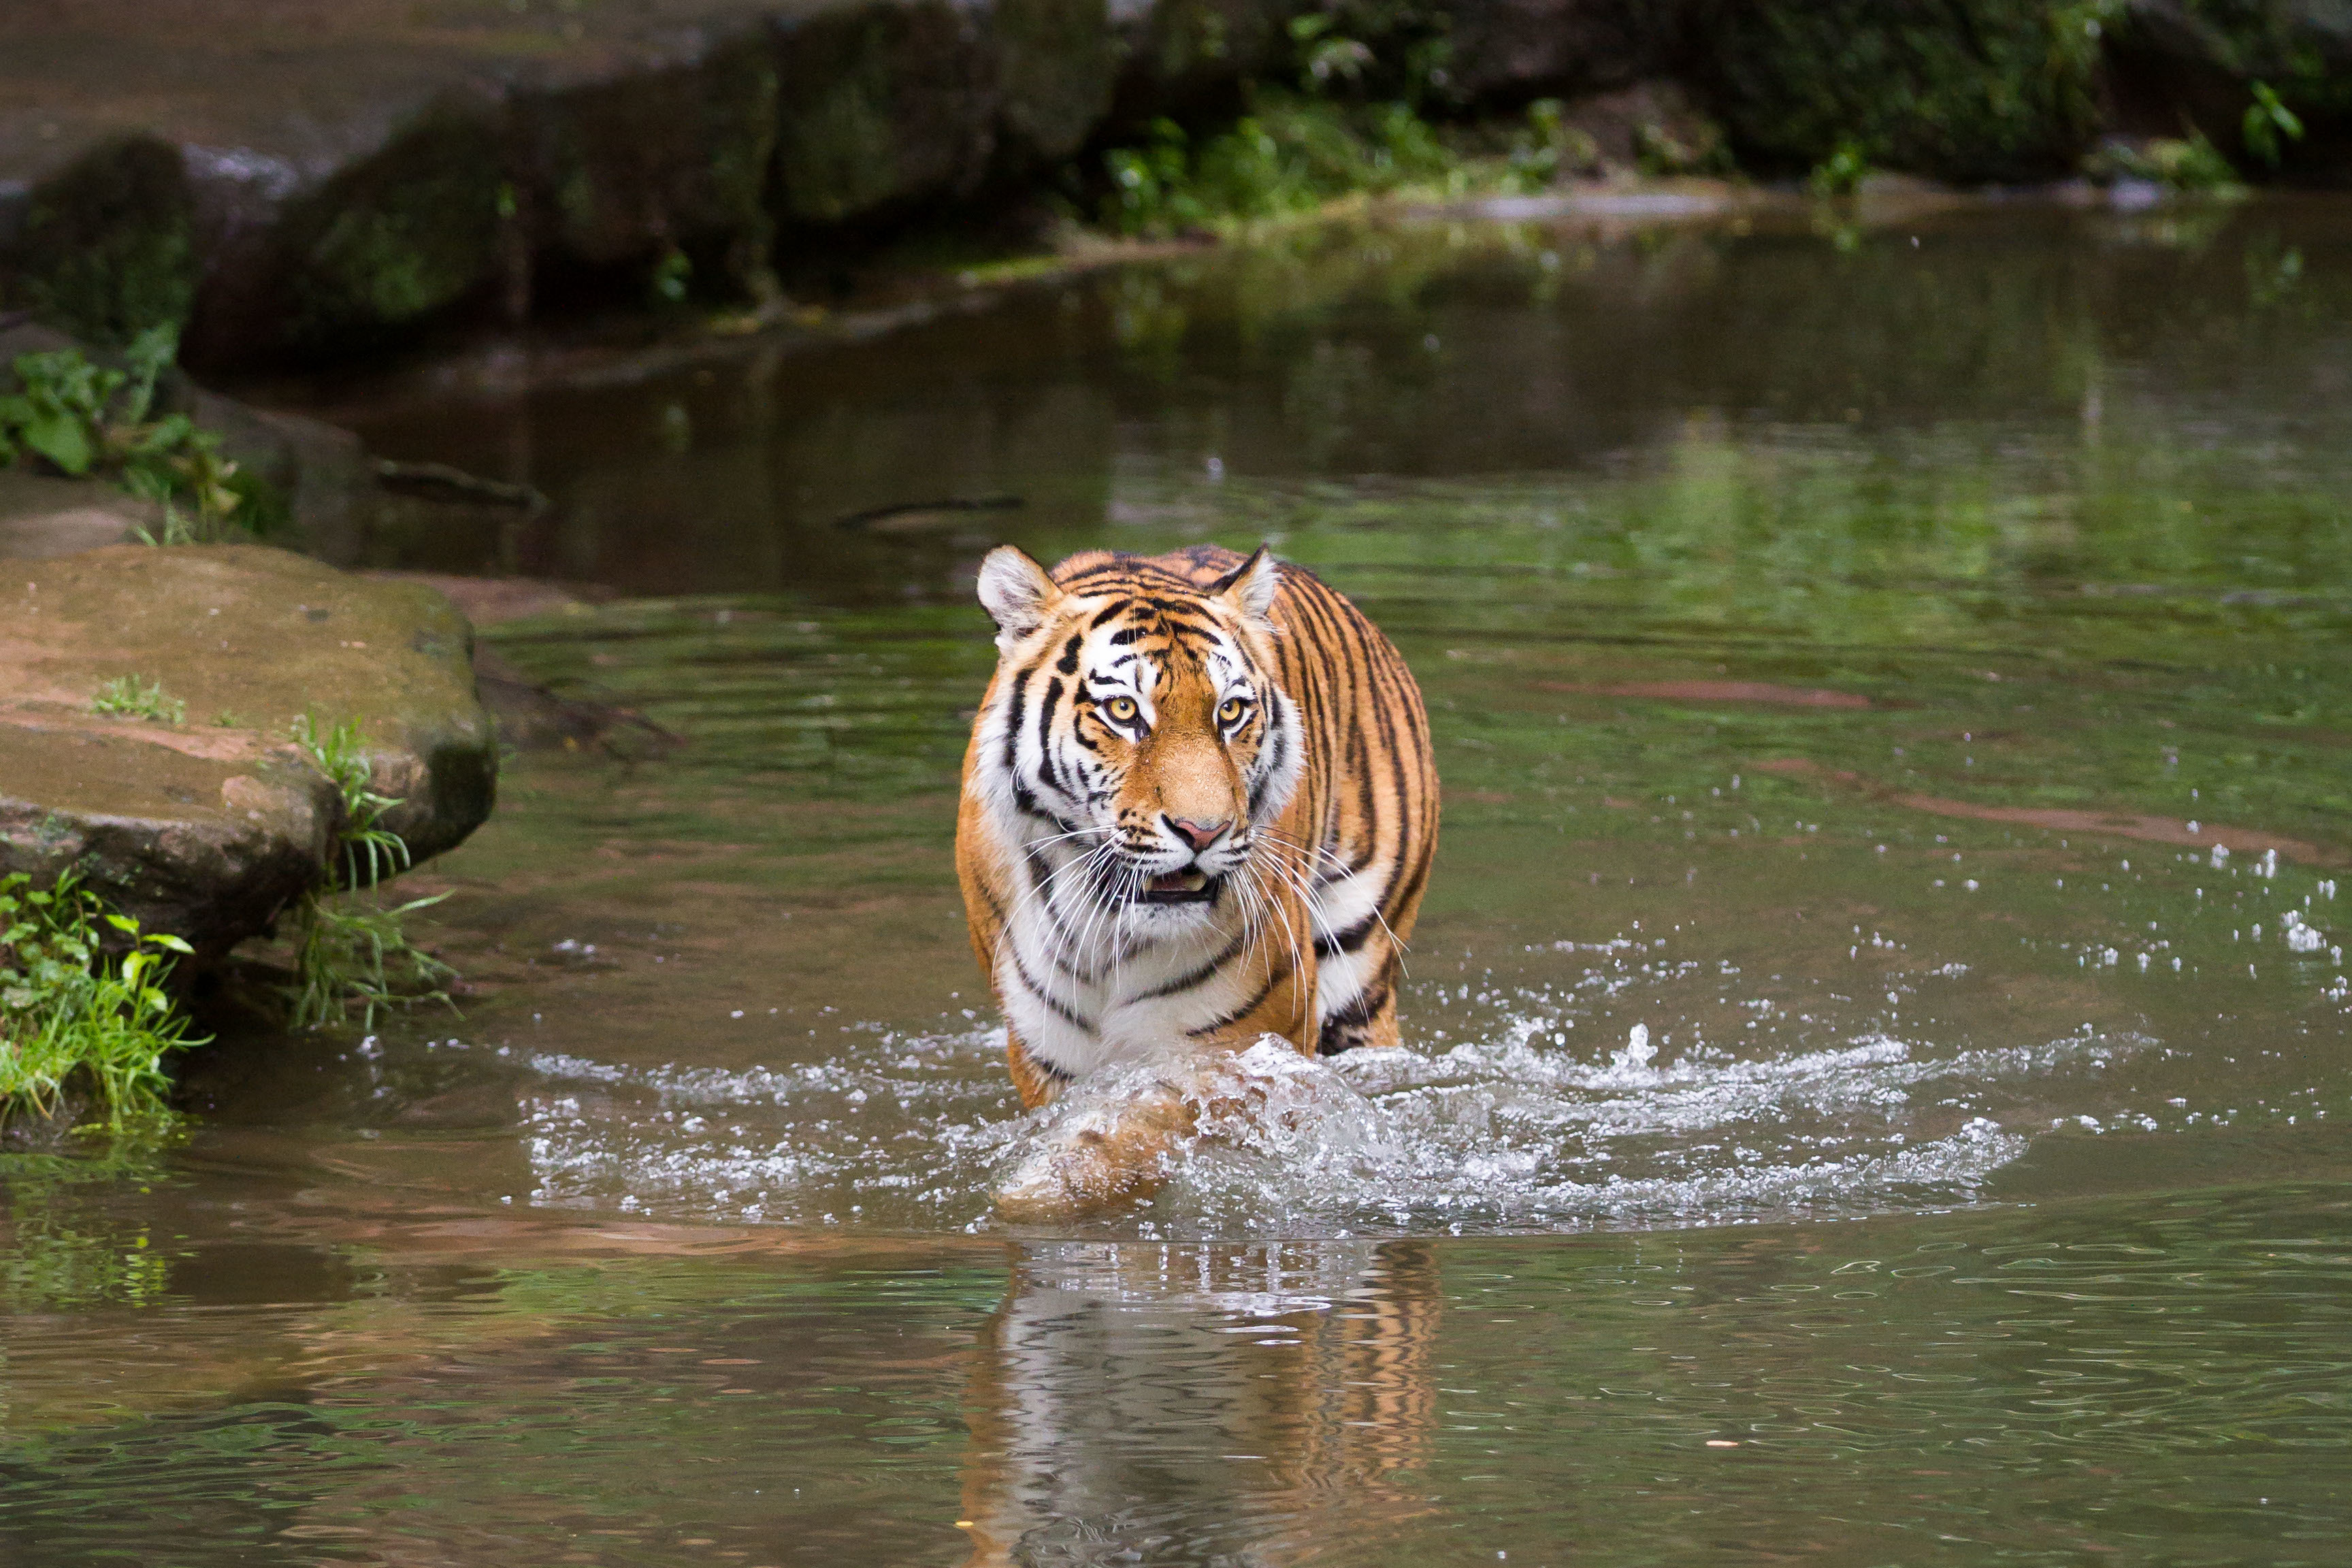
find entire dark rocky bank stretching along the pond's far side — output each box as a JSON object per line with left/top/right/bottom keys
{"left": 0, "top": 0, "right": 2352, "bottom": 369}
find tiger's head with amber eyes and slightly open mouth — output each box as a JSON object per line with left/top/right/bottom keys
{"left": 974, "top": 545, "right": 1303, "bottom": 933}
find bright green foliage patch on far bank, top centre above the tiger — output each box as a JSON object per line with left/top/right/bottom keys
{"left": 1103, "top": 94, "right": 1460, "bottom": 235}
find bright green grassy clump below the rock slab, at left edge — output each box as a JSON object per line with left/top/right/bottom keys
{"left": 0, "top": 872, "right": 202, "bottom": 1126}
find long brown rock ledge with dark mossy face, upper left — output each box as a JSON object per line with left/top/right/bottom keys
{"left": 0, "top": 0, "right": 1157, "bottom": 367}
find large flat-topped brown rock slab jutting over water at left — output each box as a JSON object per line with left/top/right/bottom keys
{"left": 0, "top": 545, "right": 496, "bottom": 954}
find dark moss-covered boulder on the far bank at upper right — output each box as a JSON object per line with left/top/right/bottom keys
{"left": 1693, "top": 0, "right": 2121, "bottom": 183}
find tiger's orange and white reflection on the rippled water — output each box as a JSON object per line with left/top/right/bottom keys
{"left": 964, "top": 1241, "right": 1442, "bottom": 1568}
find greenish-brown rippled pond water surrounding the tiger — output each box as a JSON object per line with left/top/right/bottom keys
{"left": 0, "top": 202, "right": 2352, "bottom": 1566}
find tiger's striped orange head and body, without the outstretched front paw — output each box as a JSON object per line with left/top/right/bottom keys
{"left": 955, "top": 545, "right": 1437, "bottom": 1105}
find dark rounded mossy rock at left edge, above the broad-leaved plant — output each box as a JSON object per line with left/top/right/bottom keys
{"left": 10, "top": 136, "right": 195, "bottom": 348}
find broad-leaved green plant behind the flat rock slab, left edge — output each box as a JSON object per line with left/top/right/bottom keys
{"left": 0, "top": 327, "right": 252, "bottom": 543}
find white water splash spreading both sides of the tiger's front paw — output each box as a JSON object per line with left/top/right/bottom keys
{"left": 501, "top": 1015, "right": 2145, "bottom": 1239}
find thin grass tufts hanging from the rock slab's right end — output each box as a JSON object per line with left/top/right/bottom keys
{"left": 284, "top": 713, "right": 456, "bottom": 1030}
